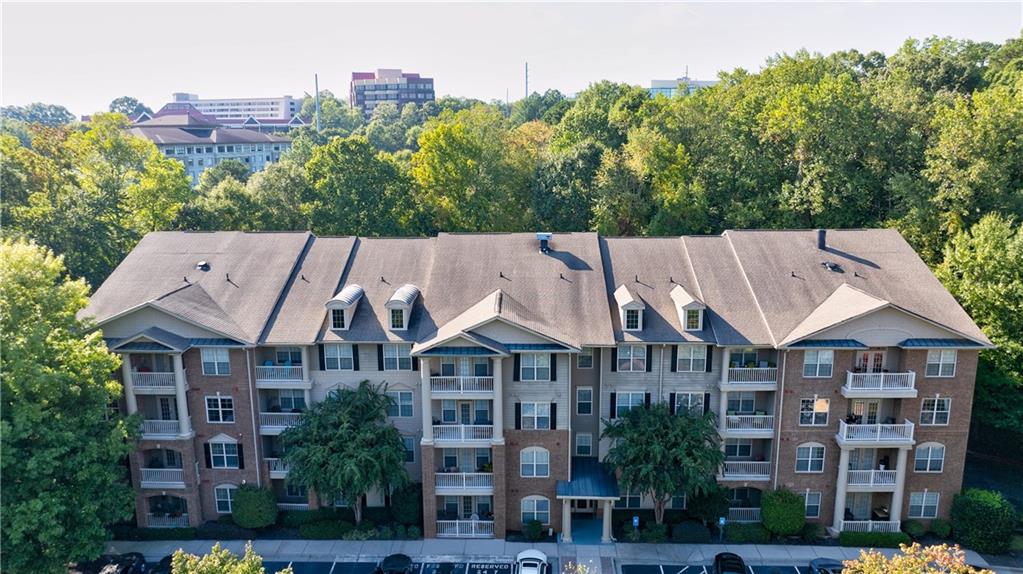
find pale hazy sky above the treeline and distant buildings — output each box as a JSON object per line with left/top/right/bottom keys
{"left": 0, "top": 0, "right": 1023, "bottom": 115}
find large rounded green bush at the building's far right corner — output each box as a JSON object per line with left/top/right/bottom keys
{"left": 951, "top": 488, "right": 1016, "bottom": 554}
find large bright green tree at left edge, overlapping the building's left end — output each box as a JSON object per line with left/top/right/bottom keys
{"left": 0, "top": 238, "right": 137, "bottom": 573}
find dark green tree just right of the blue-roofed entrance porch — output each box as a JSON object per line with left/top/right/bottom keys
{"left": 603, "top": 403, "right": 724, "bottom": 524}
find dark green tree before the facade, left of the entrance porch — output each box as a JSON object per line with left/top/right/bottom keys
{"left": 280, "top": 381, "right": 408, "bottom": 524}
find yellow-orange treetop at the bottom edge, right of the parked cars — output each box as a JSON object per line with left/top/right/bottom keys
{"left": 842, "top": 543, "right": 994, "bottom": 574}
